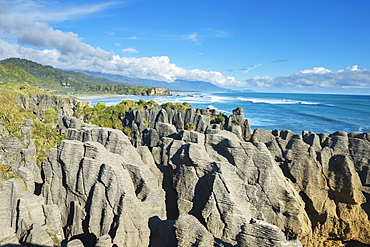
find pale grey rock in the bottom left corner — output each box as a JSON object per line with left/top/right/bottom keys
{"left": 0, "top": 177, "right": 64, "bottom": 246}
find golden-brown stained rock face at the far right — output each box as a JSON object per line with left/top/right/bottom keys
{"left": 252, "top": 130, "right": 370, "bottom": 245}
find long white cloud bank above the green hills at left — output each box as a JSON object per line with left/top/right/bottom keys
{"left": 0, "top": 12, "right": 239, "bottom": 86}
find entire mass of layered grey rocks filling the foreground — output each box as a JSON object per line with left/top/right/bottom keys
{"left": 0, "top": 95, "right": 370, "bottom": 247}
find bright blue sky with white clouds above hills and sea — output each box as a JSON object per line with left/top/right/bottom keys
{"left": 0, "top": 0, "right": 370, "bottom": 94}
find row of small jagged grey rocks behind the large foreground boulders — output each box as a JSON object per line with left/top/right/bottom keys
{"left": 121, "top": 105, "right": 252, "bottom": 147}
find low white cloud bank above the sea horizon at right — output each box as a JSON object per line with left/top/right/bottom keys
{"left": 245, "top": 65, "right": 370, "bottom": 89}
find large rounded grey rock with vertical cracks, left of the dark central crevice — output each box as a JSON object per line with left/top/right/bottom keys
{"left": 43, "top": 128, "right": 165, "bottom": 246}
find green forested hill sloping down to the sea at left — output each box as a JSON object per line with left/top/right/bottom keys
{"left": 0, "top": 58, "right": 170, "bottom": 95}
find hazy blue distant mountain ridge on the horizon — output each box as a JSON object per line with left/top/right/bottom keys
{"left": 83, "top": 71, "right": 232, "bottom": 92}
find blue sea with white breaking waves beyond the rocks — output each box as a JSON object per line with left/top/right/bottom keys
{"left": 81, "top": 92, "right": 370, "bottom": 134}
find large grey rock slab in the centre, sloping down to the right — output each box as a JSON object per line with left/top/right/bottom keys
{"left": 162, "top": 130, "right": 310, "bottom": 244}
